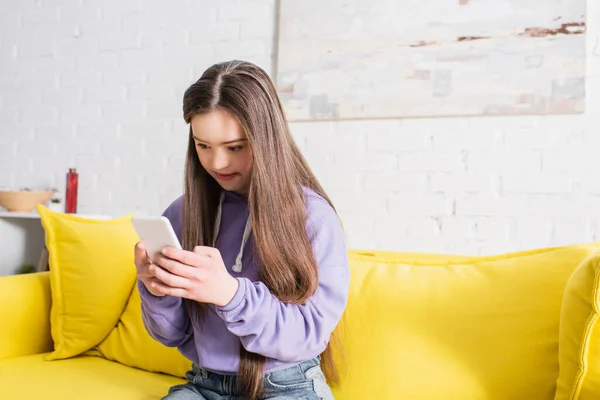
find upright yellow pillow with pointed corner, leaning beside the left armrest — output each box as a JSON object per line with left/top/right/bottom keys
{"left": 37, "top": 205, "right": 139, "bottom": 360}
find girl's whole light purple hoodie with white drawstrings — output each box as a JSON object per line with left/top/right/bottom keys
{"left": 138, "top": 190, "right": 350, "bottom": 374}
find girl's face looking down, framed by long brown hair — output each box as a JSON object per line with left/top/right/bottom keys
{"left": 190, "top": 109, "right": 252, "bottom": 196}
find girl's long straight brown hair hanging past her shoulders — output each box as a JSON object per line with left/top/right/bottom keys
{"left": 182, "top": 60, "right": 338, "bottom": 400}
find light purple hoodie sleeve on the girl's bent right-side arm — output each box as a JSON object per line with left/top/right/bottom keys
{"left": 216, "top": 197, "right": 350, "bottom": 362}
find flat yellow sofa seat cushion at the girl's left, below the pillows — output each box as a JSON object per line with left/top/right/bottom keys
{"left": 0, "top": 353, "right": 184, "bottom": 400}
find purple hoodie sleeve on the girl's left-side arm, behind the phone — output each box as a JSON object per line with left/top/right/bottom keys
{"left": 137, "top": 198, "right": 193, "bottom": 347}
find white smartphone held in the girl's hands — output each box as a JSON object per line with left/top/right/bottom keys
{"left": 131, "top": 216, "right": 181, "bottom": 260}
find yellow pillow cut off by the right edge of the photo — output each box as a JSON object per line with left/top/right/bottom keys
{"left": 555, "top": 248, "right": 600, "bottom": 400}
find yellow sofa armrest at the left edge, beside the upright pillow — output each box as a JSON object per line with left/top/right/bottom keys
{"left": 0, "top": 272, "right": 53, "bottom": 360}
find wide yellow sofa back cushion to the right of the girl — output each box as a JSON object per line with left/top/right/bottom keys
{"left": 334, "top": 243, "right": 600, "bottom": 400}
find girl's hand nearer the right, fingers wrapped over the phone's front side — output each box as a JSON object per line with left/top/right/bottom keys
{"left": 150, "top": 246, "right": 239, "bottom": 307}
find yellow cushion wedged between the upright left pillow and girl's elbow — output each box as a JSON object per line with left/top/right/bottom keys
{"left": 90, "top": 285, "right": 192, "bottom": 378}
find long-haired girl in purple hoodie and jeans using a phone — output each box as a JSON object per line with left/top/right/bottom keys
{"left": 135, "top": 61, "right": 350, "bottom": 400}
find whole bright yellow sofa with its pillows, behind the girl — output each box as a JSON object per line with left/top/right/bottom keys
{"left": 0, "top": 209, "right": 600, "bottom": 400}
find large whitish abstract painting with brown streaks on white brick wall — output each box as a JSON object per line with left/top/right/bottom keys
{"left": 276, "top": 0, "right": 586, "bottom": 121}
